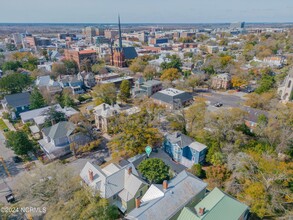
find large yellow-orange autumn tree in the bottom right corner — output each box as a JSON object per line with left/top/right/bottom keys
{"left": 229, "top": 150, "right": 293, "bottom": 218}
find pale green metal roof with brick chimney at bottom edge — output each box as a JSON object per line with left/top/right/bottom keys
{"left": 178, "top": 188, "right": 248, "bottom": 220}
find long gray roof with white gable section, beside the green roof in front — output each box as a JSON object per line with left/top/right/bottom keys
{"left": 126, "top": 171, "right": 207, "bottom": 220}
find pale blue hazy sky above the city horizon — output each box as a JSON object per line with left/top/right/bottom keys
{"left": 0, "top": 0, "right": 293, "bottom": 23}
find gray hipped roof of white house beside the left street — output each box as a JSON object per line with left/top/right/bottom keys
{"left": 43, "top": 121, "right": 75, "bottom": 139}
